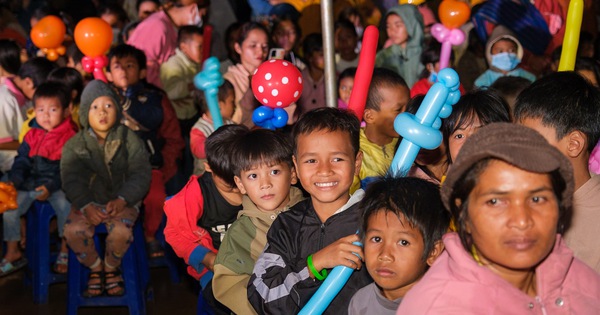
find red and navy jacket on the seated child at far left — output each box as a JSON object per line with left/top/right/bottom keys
{"left": 9, "top": 118, "right": 77, "bottom": 193}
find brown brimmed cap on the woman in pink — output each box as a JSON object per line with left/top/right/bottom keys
{"left": 441, "top": 122, "right": 575, "bottom": 209}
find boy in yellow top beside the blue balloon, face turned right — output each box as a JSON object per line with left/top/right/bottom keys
{"left": 353, "top": 68, "right": 410, "bottom": 189}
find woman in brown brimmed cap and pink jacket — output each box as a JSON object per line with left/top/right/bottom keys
{"left": 398, "top": 123, "right": 600, "bottom": 314}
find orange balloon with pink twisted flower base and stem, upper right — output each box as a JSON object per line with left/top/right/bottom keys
{"left": 431, "top": 0, "right": 471, "bottom": 69}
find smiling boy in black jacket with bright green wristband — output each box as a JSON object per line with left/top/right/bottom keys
{"left": 248, "top": 107, "right": 370, "bottom": 314}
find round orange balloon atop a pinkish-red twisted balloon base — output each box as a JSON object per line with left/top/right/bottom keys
{"left": 75, "top": 17, "right": 113, "bottom": 57}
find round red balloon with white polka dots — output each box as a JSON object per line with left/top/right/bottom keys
{"left": 252, "top": 59, "right": 302, "bottom": 108}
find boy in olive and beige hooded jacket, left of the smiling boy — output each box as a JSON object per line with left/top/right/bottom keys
{"left": 213, "top": 129, "right": 304, "bottom": 314}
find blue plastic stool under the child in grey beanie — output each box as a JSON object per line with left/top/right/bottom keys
{"left": 67, "top": 222, "right": 151, "bottom": 315}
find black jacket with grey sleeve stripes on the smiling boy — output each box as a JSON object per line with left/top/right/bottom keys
{"left": 248, "top": 190, "right": 372, "bottom": 315}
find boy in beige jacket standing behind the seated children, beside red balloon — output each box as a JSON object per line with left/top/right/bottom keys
{"left": 160, "top": 25, "right": 204, "bottom": 134}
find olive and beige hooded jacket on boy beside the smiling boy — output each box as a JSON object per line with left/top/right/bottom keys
{"left": 212, "top": 187, "right": 304, "bottom": 314}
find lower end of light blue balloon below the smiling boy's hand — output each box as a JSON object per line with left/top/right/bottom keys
{"left": 298, "top": 242, "right": 362, "bottom": 315}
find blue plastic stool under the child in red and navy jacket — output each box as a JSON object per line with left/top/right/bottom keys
{"left": 25, "top": 201, "right": 67, "bottom": 304}
